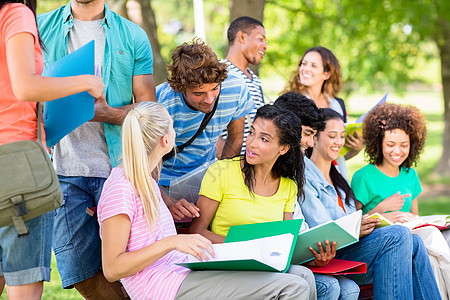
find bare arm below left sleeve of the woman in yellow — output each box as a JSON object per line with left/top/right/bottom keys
{"left": 189, "top": 195, "right": 225, "bottom": 244}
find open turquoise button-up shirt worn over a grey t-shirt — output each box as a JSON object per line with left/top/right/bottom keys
{"left": 37, "top": 2, "right": 153, "bottom": 167}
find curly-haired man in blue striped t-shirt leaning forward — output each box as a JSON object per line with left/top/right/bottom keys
{"left": 156, "top": 39, "right": 254, "bottom": 214}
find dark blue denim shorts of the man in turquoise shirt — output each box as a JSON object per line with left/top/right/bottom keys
{"left": 53, "top": 176, "right": 106, "bottom": 288}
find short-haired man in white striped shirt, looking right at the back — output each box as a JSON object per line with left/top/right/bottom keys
{"left": 217, "top": 17, "right": 267, "bottom": 156}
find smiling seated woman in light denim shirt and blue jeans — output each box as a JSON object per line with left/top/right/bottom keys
{"left": 300, "top": 109, "right": 440, "bottom": 299}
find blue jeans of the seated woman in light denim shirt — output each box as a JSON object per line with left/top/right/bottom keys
{"left": 336, "top": 225, "right": 441, "bottom": 300}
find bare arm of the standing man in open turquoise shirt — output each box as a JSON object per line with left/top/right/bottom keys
{"left": 91, "top": 74, "right": 156, "bottom": 125}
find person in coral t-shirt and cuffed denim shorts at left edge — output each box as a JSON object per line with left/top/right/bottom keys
{"left": 0, "top": 0, "right": 103, "bottom": 299}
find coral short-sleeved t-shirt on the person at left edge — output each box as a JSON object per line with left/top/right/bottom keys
{"left": 0, "top": 3, "right": 44, "bottom": 145}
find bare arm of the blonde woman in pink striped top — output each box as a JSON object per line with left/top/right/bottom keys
{"left": 102, "top": 214, "right": 214, "bottom": 282}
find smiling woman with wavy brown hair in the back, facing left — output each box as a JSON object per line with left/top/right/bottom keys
{"left": 285, "top": 46, "right": 363, "bottom": 177}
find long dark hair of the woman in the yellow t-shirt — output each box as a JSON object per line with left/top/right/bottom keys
{"left": 242, "top": 104, "right": 305, "bottom": 199}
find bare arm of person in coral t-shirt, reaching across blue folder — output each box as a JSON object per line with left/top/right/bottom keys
{"left": 6, "top": 33, "right": 104, "bottom": 102}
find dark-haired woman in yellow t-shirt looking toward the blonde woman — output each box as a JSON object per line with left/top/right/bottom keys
{"left": 190, "top": 105, "right": 316, "bottom": 299}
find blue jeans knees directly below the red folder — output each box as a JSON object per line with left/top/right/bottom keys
{"left": 314, "top": 274, "right": 359, "bottom": 300}
